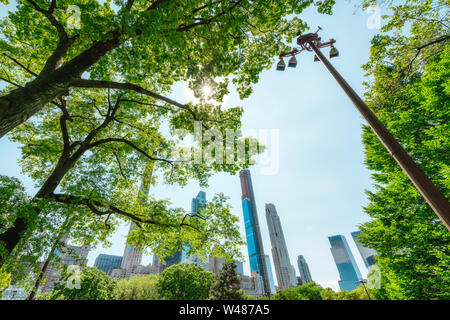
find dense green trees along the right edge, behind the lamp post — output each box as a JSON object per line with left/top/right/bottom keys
{"left": 360, "top": 1, "right": 450, "bottom": 299}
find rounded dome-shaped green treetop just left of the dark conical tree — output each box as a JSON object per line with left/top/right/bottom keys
{"left": 156, "top": 263, "right": 215, "bottom": 300}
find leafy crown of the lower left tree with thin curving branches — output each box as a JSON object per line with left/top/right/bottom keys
{"left": 2, "top": 90, "right": 250, "bottom": 272}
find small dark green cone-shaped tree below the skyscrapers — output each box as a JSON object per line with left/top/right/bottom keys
{"left": 209, "top": 262, "right": 245, "bottom": 300}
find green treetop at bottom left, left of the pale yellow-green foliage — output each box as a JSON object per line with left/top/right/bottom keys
{"left": 50, "top": 267, "right": 117, "bottom": 300}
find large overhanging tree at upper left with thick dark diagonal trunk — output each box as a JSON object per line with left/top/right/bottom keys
{"left": 0, "top": 0, "right": 335, "bottom": 137}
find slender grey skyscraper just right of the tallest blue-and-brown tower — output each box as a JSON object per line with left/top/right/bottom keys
{"left": 266, "top": 203, "right": 297, "bottom": 290}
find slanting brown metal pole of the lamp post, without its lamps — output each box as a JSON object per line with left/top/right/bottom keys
{"left": 308, "top": 41, "right": 450, "bottom": 231}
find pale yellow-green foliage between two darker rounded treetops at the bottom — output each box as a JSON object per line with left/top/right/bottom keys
{"left": 116, "top": 274, "right": 159, "bottom": 300}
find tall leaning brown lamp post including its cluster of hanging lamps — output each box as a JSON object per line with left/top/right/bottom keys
{"left": 277, "top": 27, "right": 450, "bottom": 231}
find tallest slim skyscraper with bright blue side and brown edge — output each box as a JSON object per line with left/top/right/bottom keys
{"left": 239, "top": 170, "right": 271, "bottom": 294}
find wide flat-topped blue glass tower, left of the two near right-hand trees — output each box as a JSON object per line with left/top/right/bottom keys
{"left": 328, "top": 235, "right": 362, "bottom": 291}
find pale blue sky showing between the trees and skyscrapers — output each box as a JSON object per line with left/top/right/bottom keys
{"left": 0, "top": 1, "right": 383, "bottom": 290}
